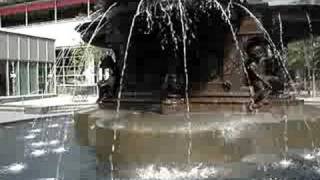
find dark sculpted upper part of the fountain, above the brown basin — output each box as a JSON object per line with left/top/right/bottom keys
{"left": 79, "top": 0, "right": 318, "bottom": 114}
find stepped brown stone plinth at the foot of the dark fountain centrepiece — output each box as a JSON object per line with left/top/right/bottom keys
{"left": 99, "top": 92, "right": 304, "bottom": 114}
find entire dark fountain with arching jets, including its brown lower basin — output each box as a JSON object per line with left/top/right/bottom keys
{"left": 71, "top": 0, "right": 320, "bottom": 179}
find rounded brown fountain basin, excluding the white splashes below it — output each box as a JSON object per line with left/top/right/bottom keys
{"left": 76, "top": 103, "right": 319, "bottom": 179}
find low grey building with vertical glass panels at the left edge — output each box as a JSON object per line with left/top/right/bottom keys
{"left": 0, "top": 30, "right": 56, "bottom": 96}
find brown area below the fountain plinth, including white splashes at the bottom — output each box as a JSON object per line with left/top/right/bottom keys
{"left": 76, "top": 106, "right": 320, "bottom": 179}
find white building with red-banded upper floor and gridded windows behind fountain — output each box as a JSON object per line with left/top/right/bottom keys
{"left": 0, "top": 0, "right": 99, "bottom": 94}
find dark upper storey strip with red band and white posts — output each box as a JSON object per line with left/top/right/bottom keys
{"left": 0, "top": 0, "right": 93, "bottom": 27}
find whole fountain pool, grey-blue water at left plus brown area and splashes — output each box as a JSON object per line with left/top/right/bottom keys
{"left": 0, "top": 105, "right": 320, "bottom": 180}
